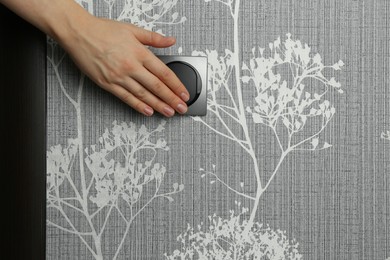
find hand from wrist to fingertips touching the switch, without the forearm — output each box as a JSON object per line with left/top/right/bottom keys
{"left": 63, "top": 17, "right": 189, "bottom": 117}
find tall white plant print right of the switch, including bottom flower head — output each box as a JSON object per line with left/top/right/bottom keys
{"left": 166, "top": 0, "right": 344, "bottom": 259}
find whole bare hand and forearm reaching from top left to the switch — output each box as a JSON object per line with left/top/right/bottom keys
{"left": 0, "top": 0, "right": 189, "bottom": 117}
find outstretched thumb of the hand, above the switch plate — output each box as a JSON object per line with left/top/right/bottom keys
{"left": 133, "top": 26, "right": 176, "bottom": 48}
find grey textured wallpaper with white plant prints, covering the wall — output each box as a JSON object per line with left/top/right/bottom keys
{"left": 47, "top": 0, "right": 390, "bottom": 260}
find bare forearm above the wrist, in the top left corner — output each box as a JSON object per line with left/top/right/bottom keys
{"left": 0, "top": 0, "right": 91, "bottom": 43}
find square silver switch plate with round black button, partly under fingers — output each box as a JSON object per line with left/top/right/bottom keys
{"left": 157, "top": 55, "right": 208, "bottom": 116}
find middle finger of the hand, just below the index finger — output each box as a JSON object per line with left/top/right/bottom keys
{"left": 131, "top": 68, "right": 188, "bottom": 114}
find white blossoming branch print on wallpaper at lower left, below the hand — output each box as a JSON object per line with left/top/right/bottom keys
{"left": 47, "top": 121, "right": 184, "bottom": 259}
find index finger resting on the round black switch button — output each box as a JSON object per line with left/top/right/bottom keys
{"left": 143, "top": 55, "right": 190, "bottom": 102}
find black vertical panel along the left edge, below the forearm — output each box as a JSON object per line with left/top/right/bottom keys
{"left": 0, "top": 5, "right": 46, "bottom": 260}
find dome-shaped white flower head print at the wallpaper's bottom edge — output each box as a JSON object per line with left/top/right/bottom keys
{"left": 165, "top": 202, "right": 302, "bottom": 260}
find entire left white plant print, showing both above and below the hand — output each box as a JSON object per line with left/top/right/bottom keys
{"left": 47, "top": 0, "right": 185, "bottom": 260}
